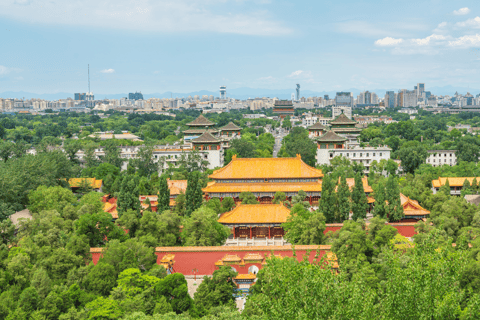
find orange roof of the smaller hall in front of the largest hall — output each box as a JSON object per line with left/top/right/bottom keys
{"left": 218, "top": 204, "right": 290, "bottom": 224}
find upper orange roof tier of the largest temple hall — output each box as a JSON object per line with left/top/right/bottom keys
{"left": 209, "top": 155, "right": 323, "bottom": 179}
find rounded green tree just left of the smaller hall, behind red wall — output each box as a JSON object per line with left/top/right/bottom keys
{"left": 181, "top": 206, "right": 230, "bottom": 246}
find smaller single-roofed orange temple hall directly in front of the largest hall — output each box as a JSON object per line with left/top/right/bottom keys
{"left": 218, "top": 204, "right": 290, "bottom": 246}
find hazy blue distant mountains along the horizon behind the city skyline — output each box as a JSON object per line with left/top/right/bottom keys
{"left": 0, "top": 85, "right": 480, "bottom": 100}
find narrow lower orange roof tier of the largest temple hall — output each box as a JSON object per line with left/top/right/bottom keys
{"left": 202, "top": 181, "right": 322, "bottom": 193}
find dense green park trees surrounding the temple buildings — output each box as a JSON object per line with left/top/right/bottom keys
{"left": 0, "top": 111, "right": 480, "bottom": 320}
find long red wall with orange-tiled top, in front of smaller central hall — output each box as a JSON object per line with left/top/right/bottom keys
{"left": 155, "top": 246, "right": 330, "bottom": 275}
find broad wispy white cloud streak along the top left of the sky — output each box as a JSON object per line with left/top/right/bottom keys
{"left": 0, "top": 0, "right": 293, "bottom": 36}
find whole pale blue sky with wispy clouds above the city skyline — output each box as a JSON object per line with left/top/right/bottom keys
{"left": 0, "top": 0, "right": 480, "bottom": 93}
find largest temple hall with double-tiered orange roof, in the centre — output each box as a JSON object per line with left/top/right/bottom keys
{"left": 202, "top": 155, "right": 323, "bottom": 205}
